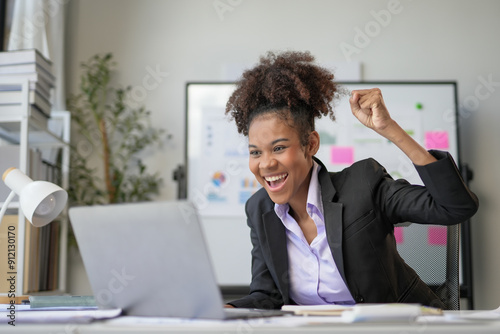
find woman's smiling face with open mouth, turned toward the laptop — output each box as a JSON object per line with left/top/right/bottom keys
{"left": 248, "top": 112, "right": 319, "bottom": 207}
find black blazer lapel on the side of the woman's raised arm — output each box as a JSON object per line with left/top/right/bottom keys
{"left": 314, "top": 158, "right": 347, "bottom": 283}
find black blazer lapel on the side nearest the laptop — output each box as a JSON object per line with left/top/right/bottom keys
{"left": 262, "top": 210, "right": 289, "bottom": 303}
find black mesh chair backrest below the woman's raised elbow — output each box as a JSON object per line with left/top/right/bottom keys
{"left": 395, "top": 224, "right": 460, "bottom": 310}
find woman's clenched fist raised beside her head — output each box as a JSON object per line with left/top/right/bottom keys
{"left": 349, "top": 88, "right": 395, "bottom": 135}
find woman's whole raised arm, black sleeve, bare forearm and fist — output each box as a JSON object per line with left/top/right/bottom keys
{"left": 349, "top": 88, "right": 478, "bottom": 225}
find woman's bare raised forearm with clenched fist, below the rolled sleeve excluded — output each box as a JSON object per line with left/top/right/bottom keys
{"left": 349, "top": 88, "right": 436, "bottom": 166}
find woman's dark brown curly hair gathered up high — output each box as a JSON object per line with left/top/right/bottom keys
{"left": 226, "top": 51, "right": 337, "bottom": 145}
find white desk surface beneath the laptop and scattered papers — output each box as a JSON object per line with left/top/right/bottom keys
{"left": 0, "top": 312, "right": 500, "bottom": 334}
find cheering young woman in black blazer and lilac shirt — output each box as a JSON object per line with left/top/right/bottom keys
{"left": 226, "top": 52, "right": 478, "bottom": 308}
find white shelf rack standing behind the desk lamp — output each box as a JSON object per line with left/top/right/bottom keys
{"left": 0, "top": 78, "right": 71, "bottom": 295}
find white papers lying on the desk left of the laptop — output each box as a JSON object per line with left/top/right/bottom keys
{"left": 0, "top": 304, "right": 122, "bottom": 324}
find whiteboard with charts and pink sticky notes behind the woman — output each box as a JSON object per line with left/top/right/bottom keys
{"left": 186, "top": 82, "right": 459, "bottom": 285}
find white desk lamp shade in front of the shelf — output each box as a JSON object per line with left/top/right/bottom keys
{"left": 2, "top": 168, "right": 68, "bottom": 227}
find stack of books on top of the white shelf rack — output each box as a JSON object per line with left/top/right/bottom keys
{"left": 0, "top": 49, "right": 55, "bottom": 127}
